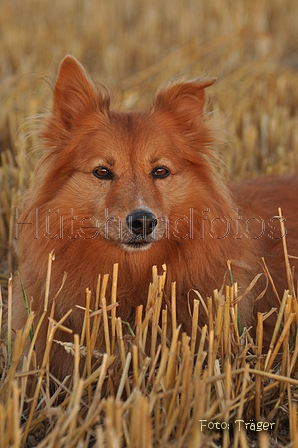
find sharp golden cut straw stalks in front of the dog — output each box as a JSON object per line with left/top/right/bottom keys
{"left": 0, "top": 256, "right": 298, "bottom": 448}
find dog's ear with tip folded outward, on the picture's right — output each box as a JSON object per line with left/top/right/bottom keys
{"left": 153, "top": 78, "right": 216, "bottom": 127}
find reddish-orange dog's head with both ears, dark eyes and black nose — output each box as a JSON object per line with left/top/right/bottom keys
{"left": 35, "top": 57, "right": 214, "bottom": 251}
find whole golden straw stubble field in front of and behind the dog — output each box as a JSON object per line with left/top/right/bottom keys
{"left": 0, "top": 0, "right": 298, "bottom": 448}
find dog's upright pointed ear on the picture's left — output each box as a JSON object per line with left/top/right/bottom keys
{"left": 54, "top": 55, "right": 109, "bottom": 130}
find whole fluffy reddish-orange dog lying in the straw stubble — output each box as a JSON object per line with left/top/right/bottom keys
{"left": 13, "top": 56, "right": 298, "bottom": 377}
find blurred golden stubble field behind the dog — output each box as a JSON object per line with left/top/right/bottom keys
{"left": 0, "top": 0, "right": 298, "bottom": 278}
